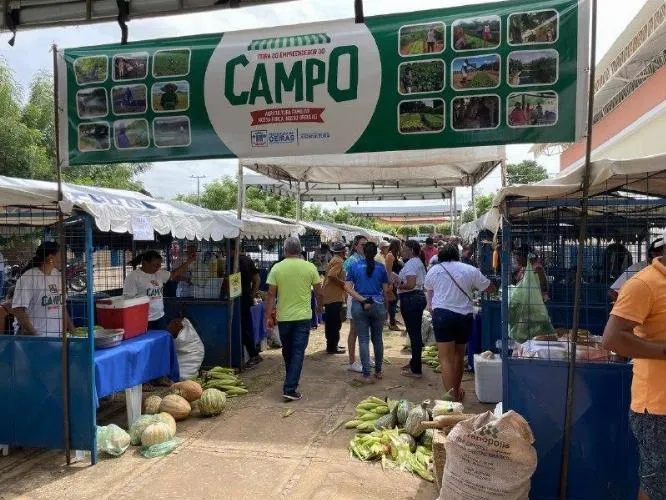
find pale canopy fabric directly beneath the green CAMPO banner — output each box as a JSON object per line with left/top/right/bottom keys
{"left": 241, "top": 146, "right": 506, "bottom": 189}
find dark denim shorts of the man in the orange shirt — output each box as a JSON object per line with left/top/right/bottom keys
{"left": 629, "top": 411, "right": 666, "bottom": 500}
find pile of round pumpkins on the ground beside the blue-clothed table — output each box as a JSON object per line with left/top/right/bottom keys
{"left": 129, "top": 380, "right": 227, "bottom": 457}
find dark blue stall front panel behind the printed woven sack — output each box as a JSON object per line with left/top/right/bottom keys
{"left": 503, "top": 358, "right": 638, "bottom": 500}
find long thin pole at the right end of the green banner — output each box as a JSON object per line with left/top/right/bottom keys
{"left": 560, "top": 0, "right": 597, "bottom": 500}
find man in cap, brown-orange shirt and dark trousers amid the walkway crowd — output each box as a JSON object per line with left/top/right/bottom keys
{"left": 323, "top": 241, "right": 347, "bottom": 354}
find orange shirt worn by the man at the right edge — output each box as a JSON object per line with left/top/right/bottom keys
{"left": 611, "top": 258, "right": 666, "bottom": 415}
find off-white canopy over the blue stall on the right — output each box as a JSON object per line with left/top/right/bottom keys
{"left": 465, "top": 154, "right": 666, "bottom": 237}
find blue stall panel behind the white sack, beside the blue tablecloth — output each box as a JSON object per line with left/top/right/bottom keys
{"left": 164, "top": 299, "right": 243, "bottom": 368}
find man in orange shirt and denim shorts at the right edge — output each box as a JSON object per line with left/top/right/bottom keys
{"left": 603, "top": 234, "right": 666, "bottom": 500}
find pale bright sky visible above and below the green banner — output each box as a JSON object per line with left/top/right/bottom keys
{"left": 0, "top": 0, "right": 645, "bottom": 207}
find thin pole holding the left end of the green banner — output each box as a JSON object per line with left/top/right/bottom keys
{"left": 51, "top": 44, "right": 72, "bottom": 465}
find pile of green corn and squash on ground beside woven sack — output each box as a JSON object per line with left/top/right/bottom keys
{"left": 345, "top": 396, "right": 463, "bottom": 481}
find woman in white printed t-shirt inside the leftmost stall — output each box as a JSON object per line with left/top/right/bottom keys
{"left": 12, "top": 242, "right": 74, "bottom": 337}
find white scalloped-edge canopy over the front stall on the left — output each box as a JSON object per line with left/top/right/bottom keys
{"left": 0, "top": 176, "right": 243, "bottom": 241}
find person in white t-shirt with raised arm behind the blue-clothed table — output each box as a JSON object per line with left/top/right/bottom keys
{"left": 123, "top": 247, "right": 197, "bottom": 330}
